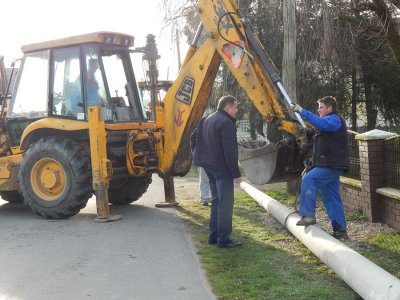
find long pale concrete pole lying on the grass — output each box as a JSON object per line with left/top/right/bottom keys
{"left": 240, "top": 182, "right": 400, "bottom": 300}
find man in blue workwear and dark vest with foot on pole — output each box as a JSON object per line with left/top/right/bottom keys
{"left": 294, "top": 96, "right": 349, "bottom": 238}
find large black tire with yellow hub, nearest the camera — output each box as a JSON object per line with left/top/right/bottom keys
{"left": 19, "top": 136, "right": 92, "bottom": 219}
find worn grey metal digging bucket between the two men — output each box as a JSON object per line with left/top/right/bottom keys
{"left": 239, "top": 142, "right": 303, "bottom": 185}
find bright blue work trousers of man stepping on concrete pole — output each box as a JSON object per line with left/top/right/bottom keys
{"left": 300, "top": 167, "right": 346, "bottom": 231}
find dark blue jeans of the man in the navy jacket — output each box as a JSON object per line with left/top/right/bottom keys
{"left": 205, "top": 168, "right": 233, "bottom": 245}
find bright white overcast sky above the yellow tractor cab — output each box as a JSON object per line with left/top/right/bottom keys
{"left": 0, "top": 0, "right": 185, "bottom": 80}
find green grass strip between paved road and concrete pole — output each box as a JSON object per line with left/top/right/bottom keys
{"left": 178, "top": 192, "right": 357, "bottom": 300}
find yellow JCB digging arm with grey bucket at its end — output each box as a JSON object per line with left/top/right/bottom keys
{"left": 159, "top": 0, "right": 307, "bottom": 183}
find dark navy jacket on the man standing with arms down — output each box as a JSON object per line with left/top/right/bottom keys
{"left": 190, "top": 110, "right": 240, "bottom": 178}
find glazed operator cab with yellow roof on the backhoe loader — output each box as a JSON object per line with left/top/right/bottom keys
{"left": 6, "top": 32, "right": 146, "bottom": 145}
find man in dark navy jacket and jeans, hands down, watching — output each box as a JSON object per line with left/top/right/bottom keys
{"left": 190, "top": 96, "right": 241, "bottom": 248}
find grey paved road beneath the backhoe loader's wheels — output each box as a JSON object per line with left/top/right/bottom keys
{"left": 0, "top": 175, "right": 214, "bottom": 300}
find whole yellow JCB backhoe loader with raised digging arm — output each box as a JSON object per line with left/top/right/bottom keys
{"left": 0, "top": 0, "right": 308, "bottom": 220}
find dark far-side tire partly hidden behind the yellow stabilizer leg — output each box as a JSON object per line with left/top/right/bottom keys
{"left": 108, "top": 175, "right": 152, "bottom": 205}
